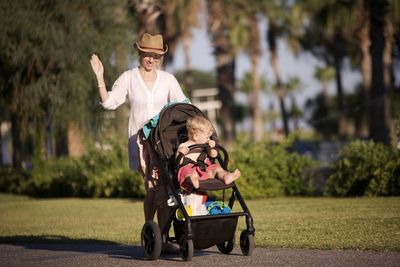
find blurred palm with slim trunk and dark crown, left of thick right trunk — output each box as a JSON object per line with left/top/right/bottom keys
{"left": 300, "top": 0, "right": 357, "bottom": 138}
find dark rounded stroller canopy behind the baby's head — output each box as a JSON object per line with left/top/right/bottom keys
{"left": 150, "top": 103, "right": 216, "bottom": 160}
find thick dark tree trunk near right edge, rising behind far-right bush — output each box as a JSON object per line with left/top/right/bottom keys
{"left": 369, "top": 0, "right": 390, "bottom": 144}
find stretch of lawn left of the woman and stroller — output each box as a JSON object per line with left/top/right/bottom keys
{"left": 0, "top": 195, "right": 144, "bottom": 247}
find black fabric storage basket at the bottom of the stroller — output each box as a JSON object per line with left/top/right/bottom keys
{"left": 174, "top": 212, "right": 243, "bottom": 249}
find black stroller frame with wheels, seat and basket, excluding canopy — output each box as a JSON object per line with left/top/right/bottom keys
{"left": 141, "top": 104, "right": 255, "bottom": 261}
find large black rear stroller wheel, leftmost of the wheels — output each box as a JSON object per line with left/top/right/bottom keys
{"left": 141, "top": 221, "right": 162, "bottom": 260}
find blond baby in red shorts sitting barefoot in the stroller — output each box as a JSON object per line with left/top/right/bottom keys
{"left": 177, "top": 116, "right": 240, "bottom": 191}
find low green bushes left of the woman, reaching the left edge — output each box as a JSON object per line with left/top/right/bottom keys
{"left": 0, "top": 140, "right": 145, "bottom": 198}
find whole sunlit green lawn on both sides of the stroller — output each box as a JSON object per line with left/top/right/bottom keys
{"left": 0, "top": 194, "right": 400, "bottom": 251}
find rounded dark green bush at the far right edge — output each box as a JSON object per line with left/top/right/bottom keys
{"left": 326, "top": 141, "right": 400, "bottom": 196}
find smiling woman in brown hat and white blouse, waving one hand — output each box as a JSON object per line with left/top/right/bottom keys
{"left": 90, "top": 33, "right": 186, "bottom": 229}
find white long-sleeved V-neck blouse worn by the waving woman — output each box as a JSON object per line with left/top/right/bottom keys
{"left": 101, "top": 67, "right": 186, "bottom": 137}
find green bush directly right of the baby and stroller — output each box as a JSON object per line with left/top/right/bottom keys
{"left": 229, "top": 137, "right": 315, "bottom": 199}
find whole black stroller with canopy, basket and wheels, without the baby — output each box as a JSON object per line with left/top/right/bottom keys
{"left": 141, "top": 103, "right": 255, "bottom": 261}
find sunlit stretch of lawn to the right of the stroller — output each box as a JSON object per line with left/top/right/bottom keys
{"left": 240, "top": 198, "right": 400, "bottom": 250}
